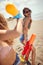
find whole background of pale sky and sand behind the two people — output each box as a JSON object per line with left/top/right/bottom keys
{"left": 0, "top": 0, "right": 43, "bottom": 65}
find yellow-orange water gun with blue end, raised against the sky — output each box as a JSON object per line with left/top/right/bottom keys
{"left": 5, "top": 4, "right": 22, "bottom": 18}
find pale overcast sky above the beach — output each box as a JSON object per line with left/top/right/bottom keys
{"left": 0, "top": 0, "right": 43, "bottom": 20}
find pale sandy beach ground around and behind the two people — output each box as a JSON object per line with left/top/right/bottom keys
{"left": 8, "top": 20, "right": 43, "bottom": 65}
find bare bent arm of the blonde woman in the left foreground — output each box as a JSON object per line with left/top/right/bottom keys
{"left": 0, "top": 30, "right": 20, "bottom": 40}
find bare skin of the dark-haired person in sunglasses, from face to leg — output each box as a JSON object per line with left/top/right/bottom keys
{"left": 22, "top": 8, "right": 36, "bottom": 65}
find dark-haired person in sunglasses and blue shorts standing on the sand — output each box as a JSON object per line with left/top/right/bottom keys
{"left": 20, "top": 8, "right": 36, "bottom": 65}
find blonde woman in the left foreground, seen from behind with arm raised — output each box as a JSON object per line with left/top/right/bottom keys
{"left": 0, "top": 14, "right": 23, "bottom": 65}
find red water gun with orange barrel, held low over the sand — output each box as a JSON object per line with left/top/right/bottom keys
{"left": 20, "top": 34, "right": 36, "bottom": 62}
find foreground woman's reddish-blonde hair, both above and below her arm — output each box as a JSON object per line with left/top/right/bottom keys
{"left": 0, "top": 14, "right": 12, "bottom": 44}
